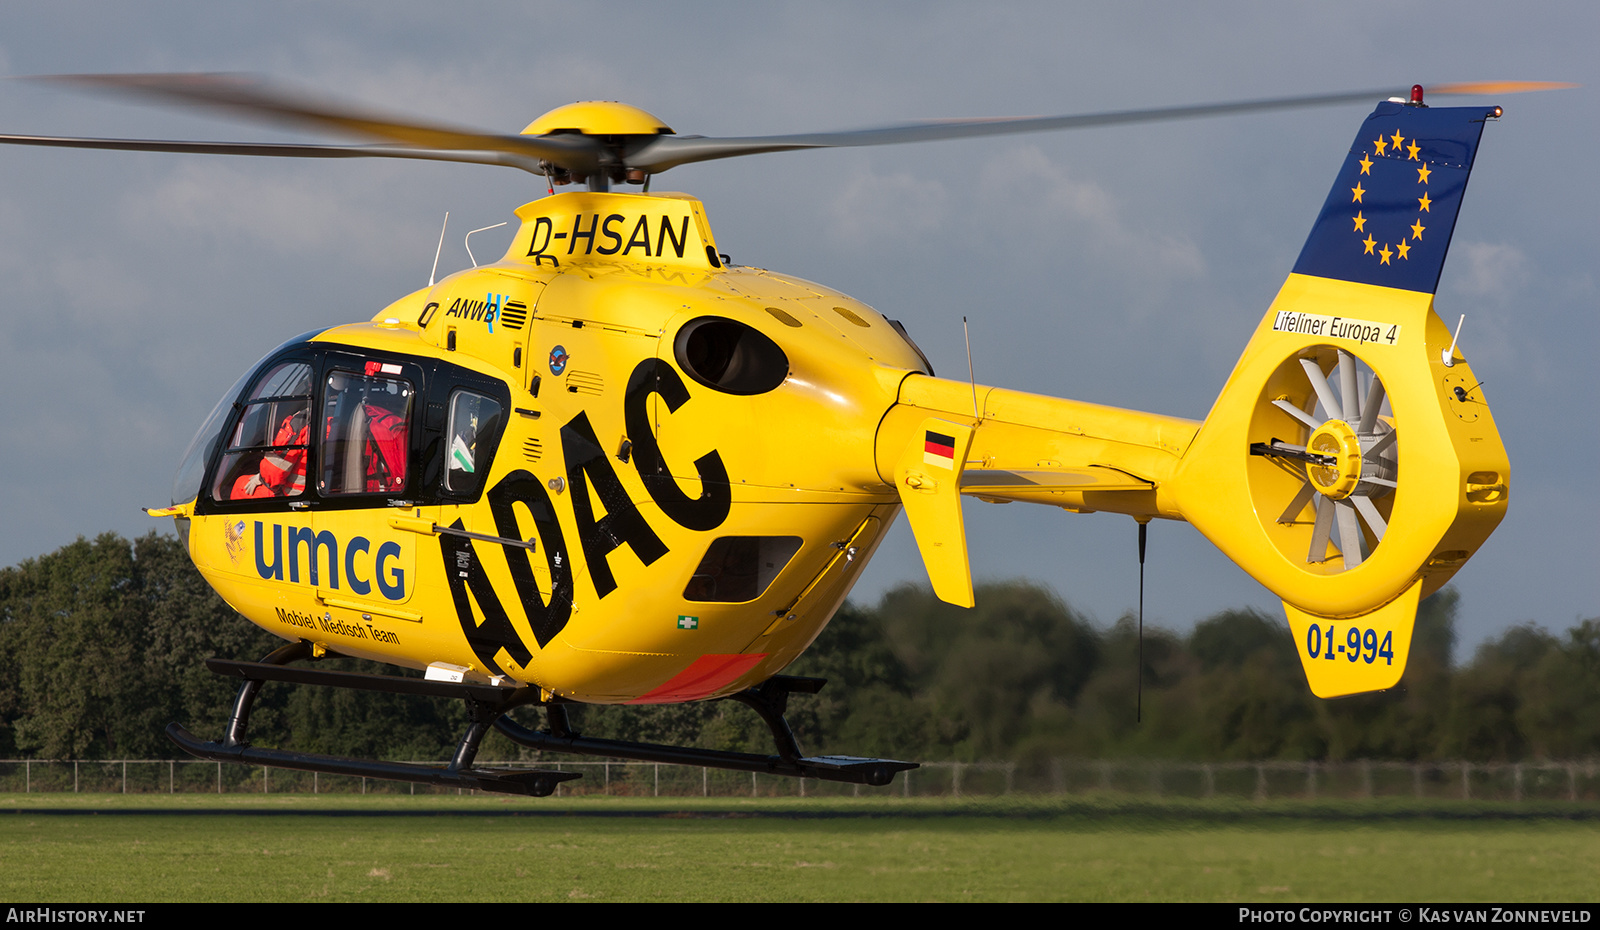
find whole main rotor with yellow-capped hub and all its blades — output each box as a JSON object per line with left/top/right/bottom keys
{"left": 0, "top": 74, "right": 1573, "bottom": 190}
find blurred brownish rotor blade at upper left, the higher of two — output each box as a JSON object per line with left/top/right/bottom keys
{"left": 29, "top": 74, "right": 600, "bottom": 168}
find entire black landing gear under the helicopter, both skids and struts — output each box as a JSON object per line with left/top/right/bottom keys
{"left": 166, "top": 642, "right": 917, "bottom": 797}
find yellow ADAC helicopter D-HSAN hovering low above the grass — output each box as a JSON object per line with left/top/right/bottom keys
{"left": 0, "top": 75, "right": 1557, "bottom": 796}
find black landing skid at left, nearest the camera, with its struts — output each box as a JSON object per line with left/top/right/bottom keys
{"left": 166, "top": 643, "right": 581, "bottom": 797}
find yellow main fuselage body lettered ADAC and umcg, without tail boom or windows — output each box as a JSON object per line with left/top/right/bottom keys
{"left": 190, "top": 194, "right": 922, "bottom": 703}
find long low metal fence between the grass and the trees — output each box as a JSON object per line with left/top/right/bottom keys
{"left": 0, "top": 759, "right": 1600, "bottom": 802}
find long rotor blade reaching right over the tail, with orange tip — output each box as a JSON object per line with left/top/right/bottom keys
{"left": 627, "top": 82, "right": 1574, "bottom": 171}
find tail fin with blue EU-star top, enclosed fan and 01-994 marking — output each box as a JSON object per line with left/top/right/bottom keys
{"left": 1173, "top": 102, "right": 1510, "bottom": 696}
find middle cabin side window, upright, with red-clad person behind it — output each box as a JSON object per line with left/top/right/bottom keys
{"left": 317, "top": 362, "right": 416, "bottom": 496}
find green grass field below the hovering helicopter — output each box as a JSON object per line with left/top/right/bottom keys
{"left": 0, "top": 794, "right": 1600, "bottom": 903}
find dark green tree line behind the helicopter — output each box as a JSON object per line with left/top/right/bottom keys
{"left": 0, "top": 533, "right": 1600, "bottom": 764}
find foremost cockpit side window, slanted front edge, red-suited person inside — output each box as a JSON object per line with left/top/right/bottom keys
{"left": 211, "top": 362, "right": 312, "bottom": 501}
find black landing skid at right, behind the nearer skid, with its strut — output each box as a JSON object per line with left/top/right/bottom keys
{"left": 494, "top": 675, "right": 917, "bottom": 786}
